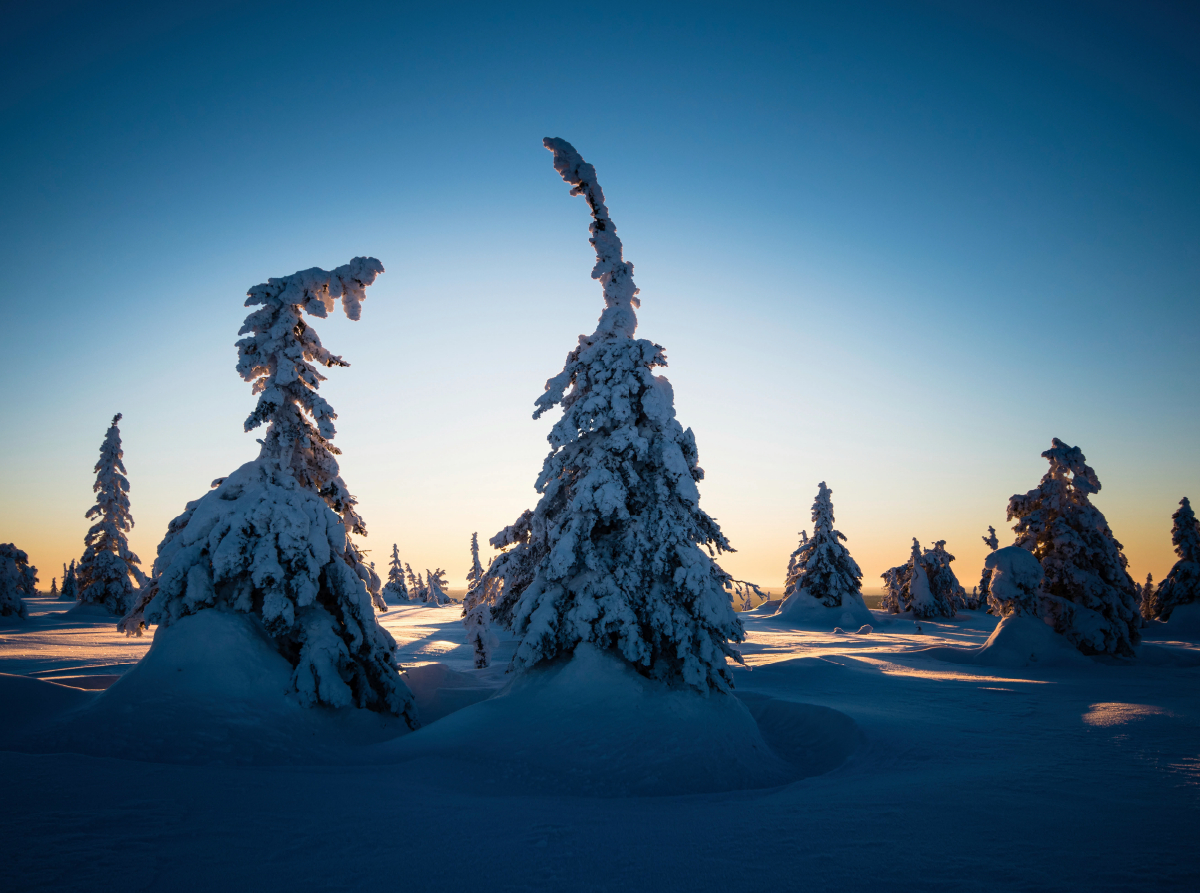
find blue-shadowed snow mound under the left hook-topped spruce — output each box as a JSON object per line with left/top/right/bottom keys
{"left": 0, "top": 609, "right": 408, "bottom": 765}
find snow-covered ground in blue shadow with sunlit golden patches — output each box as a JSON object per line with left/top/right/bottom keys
{"left": 0, "top": 599, "right": 1200, "bottom": 893}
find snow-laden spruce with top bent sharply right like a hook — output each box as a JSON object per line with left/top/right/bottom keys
{"left": 125, "top": 257, "right": 416, "bottom": 726}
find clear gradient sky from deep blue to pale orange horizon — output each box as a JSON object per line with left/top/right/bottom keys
{"left": 0, "top": 1, "right": 1200, "bottom": 592}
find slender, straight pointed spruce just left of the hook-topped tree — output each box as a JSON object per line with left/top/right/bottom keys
{"left": 77, "top": 413, "right": 145, "bottom": 616}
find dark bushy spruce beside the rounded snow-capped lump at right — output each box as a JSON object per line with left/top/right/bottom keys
{"left": 1008, "top": 437, "right": 1141, "bottom": 657}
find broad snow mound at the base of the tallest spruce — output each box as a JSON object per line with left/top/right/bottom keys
{"left": 379, "top": 645, "right": 858, "bottom": 797}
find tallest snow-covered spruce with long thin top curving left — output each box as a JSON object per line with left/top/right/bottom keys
{"left": 475, "top": 138, "right": 745, "bottom": 691}
